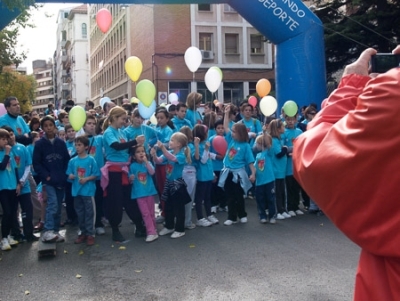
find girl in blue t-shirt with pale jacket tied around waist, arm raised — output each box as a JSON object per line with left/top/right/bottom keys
{"left": 218, "top": 105, "right": 256, "bottom": 226}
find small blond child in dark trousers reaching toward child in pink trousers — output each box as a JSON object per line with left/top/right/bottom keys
{"left": 151, "top": 132, "right": 191, "bottom": 238}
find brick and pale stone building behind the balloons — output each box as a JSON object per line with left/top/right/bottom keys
{"left": 90, "top": 4, "right": 275, "bottom": 103}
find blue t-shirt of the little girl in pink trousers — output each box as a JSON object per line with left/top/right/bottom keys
{"left": 129, "top": 162, "right": 157, "bottom": 200}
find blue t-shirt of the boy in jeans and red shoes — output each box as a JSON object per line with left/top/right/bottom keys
{"left": 66, "top": 156, "right": 100, "bottom": 197}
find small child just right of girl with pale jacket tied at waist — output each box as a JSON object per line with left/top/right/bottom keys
{"left": 254, "top": 133, "right": 276, "bottom": 224}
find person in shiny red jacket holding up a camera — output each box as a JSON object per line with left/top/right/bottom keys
{"left": 293, "top": 46, "right": 400, "bottom": 301}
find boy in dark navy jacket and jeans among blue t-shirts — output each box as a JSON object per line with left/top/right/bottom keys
{"left": 32, "top": 116, "right": 70, "bottom": 242}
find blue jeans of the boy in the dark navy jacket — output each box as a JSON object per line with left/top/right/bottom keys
{"left": 44, "top": 185, "right": 64, "bottom": 232}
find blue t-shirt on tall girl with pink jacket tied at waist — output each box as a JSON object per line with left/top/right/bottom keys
{"left": 103, "top": 126, "right": 129, "bottom": 162}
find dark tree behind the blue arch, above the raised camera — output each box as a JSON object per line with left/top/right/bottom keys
{"left": 314, "top": 0, "right": 400, "bottom": 77}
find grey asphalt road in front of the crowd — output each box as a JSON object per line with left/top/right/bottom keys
{"left": 0, "top": 200, "right": 360, "bottom": 301}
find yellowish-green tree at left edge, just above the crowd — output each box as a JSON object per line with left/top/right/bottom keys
{"left": 0, "top": 67, "right": 36, "bottom": 113}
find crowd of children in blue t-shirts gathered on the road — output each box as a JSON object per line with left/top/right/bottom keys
{"left": 0, "top": 92, "right": 316, "bottom": 250}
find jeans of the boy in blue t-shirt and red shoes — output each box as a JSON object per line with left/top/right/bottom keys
{"left": 74, "top": 195, "right": 96, "bottom": 236}
